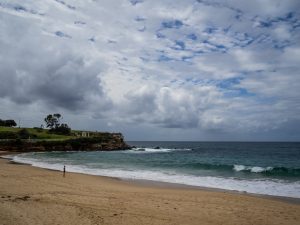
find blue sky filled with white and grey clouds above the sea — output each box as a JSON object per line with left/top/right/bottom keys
{"left": 0, "top": 0, "right": 300, "bottom": 141}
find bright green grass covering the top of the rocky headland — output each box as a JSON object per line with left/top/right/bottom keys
{"left": 0, "top": 126, "right": 75, "bottom": 140}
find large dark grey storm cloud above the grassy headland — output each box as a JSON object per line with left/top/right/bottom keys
{"left": 0, "top": 9, "right": 110, "bottom": 110}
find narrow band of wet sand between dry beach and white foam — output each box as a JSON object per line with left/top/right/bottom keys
{"left": 0, "top": 155, "right": 300, "bottom": 205}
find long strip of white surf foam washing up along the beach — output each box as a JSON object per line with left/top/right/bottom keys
{"left": 13, "top": 155, "right": 300, "bottom": 198}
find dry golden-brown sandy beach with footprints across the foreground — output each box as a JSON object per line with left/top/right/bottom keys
{"left": 0, "top": 159, "right": 300, "bottom": 225}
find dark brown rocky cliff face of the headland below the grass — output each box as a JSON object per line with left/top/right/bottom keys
{"left": 0, "top": 133, "right": 130, "bottom": 152}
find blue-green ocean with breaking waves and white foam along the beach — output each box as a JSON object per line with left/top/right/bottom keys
{"left": 8, "top": 142, "right": 300, "bottom": 198}
